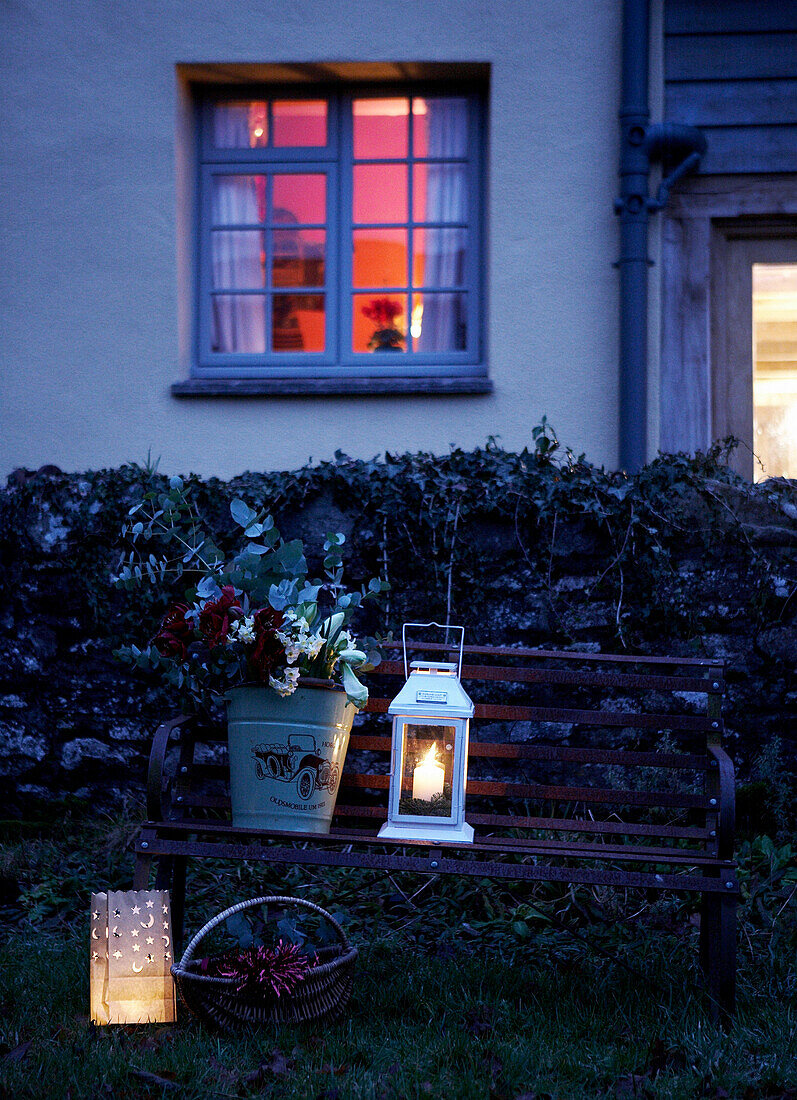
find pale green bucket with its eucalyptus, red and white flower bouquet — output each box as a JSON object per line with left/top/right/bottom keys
{"left": 115, "top": 477, "right": 387, "bottom": 833}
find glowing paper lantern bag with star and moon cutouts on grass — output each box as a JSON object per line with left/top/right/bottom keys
{"left": 90, "top": 890, "right": 176, "bottom": 1024}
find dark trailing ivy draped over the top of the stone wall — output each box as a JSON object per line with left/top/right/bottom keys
{"left": 0, "top": 418, "right": 797, "bottom": 649}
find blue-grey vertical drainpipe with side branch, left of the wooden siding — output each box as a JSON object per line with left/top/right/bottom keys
{"left": 615, "top": 0, "right": 706, "bottom": 473}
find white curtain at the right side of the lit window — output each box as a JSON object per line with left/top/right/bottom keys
{"left": 418, "top": 99, "right": 467, "bottom": 352}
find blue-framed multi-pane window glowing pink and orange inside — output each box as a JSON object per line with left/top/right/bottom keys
{"left": 195, "top": 89, "right": 485, "bottom": 391}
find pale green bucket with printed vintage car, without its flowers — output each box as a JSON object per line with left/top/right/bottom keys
{"left": 226, "top": 680, "right": 356, "bottom": 833}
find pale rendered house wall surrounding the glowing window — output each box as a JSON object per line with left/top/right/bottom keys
{"left": 0, "top": 0, "right": 621, "bottom": 476}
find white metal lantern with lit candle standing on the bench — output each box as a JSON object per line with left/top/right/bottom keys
{"left": 379, "top": 623, "right": 474, "bottom": 844}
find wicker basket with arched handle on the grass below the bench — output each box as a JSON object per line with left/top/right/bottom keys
{"left": 171, "top": 898, "right": 357, "bottom": 1031}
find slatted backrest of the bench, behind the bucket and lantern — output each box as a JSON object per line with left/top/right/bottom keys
{"left": 168, "top": 645, "right": 724, "bottom": 851}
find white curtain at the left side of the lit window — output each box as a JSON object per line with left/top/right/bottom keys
{"left": 211, "top": 105, "right": 265, "bottom": 352}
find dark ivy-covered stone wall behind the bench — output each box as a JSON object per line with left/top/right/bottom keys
{"left": 0, "top": 448, "right": 797, "bottom": 813}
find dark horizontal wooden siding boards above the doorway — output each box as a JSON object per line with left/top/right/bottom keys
{"left": 664, "top": 0, "right": 797, "bottom": 175}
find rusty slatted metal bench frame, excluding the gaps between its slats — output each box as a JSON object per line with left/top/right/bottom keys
{"left": 134, "top": 646, "right": 739, "bottom": 1021}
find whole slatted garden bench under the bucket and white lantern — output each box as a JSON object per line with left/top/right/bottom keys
{"left": 135, "top": 646, "right": 739, "bottom": 1019}
